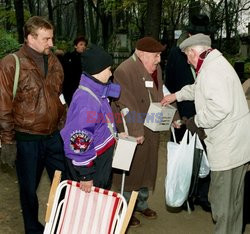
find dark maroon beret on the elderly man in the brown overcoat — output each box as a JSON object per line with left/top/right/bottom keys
{"left": 135, "top": 37, "right": 166, "bottom": 53}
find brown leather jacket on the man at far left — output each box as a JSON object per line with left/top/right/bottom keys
{"left": 0, "top": 45, "right": 65, "bottom": 144}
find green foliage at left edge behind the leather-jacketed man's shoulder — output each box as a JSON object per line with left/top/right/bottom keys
{"left": 0, "top": 29, "right": 20, "bottom": 58}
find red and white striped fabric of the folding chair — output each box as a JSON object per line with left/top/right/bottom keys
{"left": 44, "top": 180, "right": 127, "bottom": 234}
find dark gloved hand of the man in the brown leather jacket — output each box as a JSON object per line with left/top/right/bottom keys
{"left": 0, "top": 144, "right": 16, "bottom": 168}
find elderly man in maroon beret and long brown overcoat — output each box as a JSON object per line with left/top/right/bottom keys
{"left": 113, "top": 37, "right": 169, "bottom": 226}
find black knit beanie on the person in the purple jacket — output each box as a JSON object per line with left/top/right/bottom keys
{"left": 81, "top": 45, "right": 113, "bottom": 75}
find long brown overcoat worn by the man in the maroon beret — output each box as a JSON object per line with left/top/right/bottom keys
{"left": 112, "top": 54, "right": 163, "bottom": 191}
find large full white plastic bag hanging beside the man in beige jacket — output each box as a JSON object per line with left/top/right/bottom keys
{"left": 165, "top": 130, "right": 195, "bottom": 207}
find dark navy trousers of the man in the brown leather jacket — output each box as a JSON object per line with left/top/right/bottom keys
{"left": 16, "top": 132, "right": 65, "bottom": 234}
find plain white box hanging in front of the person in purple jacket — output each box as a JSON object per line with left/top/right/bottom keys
{"left": 112, "top": 136, "right": 137, "bottom": 171}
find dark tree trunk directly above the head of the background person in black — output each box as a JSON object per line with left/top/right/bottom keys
{"left": 75, "top": 0, "right": 86, "bottom": 35}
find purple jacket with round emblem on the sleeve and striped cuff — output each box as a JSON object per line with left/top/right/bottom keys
{"left": 61, "top": 74, "right": 120, "bottom": 166}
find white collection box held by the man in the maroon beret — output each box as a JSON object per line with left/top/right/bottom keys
{"left": 144, "top": 102, "right": 176, "bottom": 132}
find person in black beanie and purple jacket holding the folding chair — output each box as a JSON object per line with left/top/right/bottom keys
{"left": 61, "top": 46, "right": 120, "bottom": 192}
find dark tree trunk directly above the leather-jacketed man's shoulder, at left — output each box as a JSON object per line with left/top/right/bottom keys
{"left": 14, "top": 0, "right": 24, "bottom": 43}
